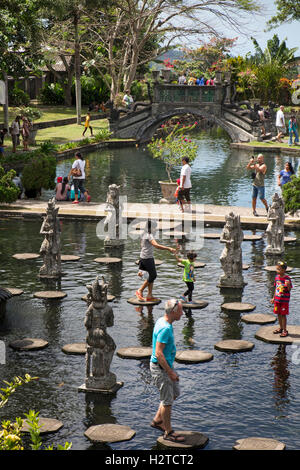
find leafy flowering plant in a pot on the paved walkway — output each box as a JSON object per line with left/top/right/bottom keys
{"left": 148, "top": 122, "right": 198, "bottom": 203}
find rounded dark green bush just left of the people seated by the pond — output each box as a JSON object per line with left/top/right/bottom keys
{"left": 21, "top": 154, "right": 56, "bottom": 198}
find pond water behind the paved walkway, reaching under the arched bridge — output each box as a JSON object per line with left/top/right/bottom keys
{"left": 48, "top": 128, "right": 299, "bottom": 207}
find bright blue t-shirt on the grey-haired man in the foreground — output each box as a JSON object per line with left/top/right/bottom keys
{"left": 151, "top": 317, "right": 176, "bottom": 367}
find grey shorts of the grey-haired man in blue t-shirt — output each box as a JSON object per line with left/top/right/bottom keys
{"left": 150, "top": 362, "right": 180, "bottom": 406}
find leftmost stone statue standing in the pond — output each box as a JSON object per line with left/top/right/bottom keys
{"left": 39, "top": 198, "right": 61, "bottom": 279}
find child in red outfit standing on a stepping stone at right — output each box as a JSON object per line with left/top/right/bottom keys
{"left": 271, "top": 261, "right": 293, "bottom": 338}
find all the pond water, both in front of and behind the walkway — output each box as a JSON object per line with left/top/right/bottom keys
{"left": 0, "top": 131, "right": 300, "bottom": 450}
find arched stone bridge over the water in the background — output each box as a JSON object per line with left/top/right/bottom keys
{"left": 110, "top": 83, "right": 260, "bottom": 143}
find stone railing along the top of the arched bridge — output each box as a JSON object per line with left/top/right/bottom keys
{"left": 153, "top": 84, "right": 223, "bottom": 104}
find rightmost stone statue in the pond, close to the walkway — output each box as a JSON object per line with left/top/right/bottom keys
{"left": 266, "top": 193, "right": 285, "bottom": 255}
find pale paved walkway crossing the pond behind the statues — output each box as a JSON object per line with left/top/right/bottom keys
{"left": 0, "top": 199, "right": 300, "bottom": 229}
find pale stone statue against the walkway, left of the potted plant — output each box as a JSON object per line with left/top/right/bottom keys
{"left": 104, "top": 184, "right": 125, "bottom": 247}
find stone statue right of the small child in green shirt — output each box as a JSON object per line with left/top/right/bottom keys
{"left": 219, "top": 212, "right": 245, "bottom": 288}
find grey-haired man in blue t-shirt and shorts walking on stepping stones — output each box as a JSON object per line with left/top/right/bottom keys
{"left": 150, "top": 299, "right": 184, "bottom": 442}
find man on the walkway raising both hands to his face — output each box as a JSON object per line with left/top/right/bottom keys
{"left": 246, "top": 153, "right": 269, "bottom": 217}
